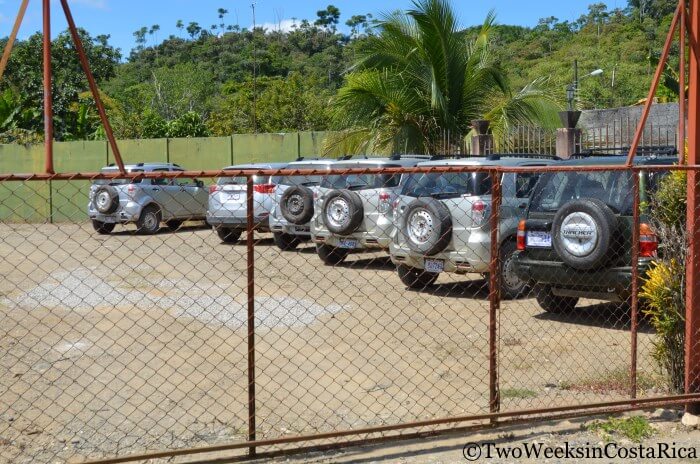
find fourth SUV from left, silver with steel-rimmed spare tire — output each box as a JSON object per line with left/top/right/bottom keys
{"left": 311, "top": 156, "right": 427, "bottom": 264}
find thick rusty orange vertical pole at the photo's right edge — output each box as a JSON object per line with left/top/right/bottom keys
{"left": 685, "top": 0, "right": 700, "bottom": 414}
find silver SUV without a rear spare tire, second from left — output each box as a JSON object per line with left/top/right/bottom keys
{"left": 207, "top": 163, "right": 289, "bottom": 243}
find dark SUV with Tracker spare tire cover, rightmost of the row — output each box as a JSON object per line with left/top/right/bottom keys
{"left": 514, "top": 156, "right": 677, "bottom": 312}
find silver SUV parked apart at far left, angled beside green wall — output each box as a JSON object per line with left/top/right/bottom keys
{"left": 88, "top": 163, "right": 207, "bottom": 234}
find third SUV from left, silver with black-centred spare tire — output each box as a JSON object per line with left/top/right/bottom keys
{"left": 270, "top": 159, "right": 336, "bottom": 251}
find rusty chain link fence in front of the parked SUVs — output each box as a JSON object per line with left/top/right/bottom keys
{"left": 0, "top": 161, "right": 698, "bottom": 462}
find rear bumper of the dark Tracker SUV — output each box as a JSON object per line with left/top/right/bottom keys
{"left": 514, "top": 252, "right": 652, "bottom": 301}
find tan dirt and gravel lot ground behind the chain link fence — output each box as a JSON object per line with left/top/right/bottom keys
{"left": 0, "top": 224, "right": 660, "bottom": 463}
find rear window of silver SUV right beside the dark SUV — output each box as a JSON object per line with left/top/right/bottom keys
{"left": 401, "top": 172, "right": 491, "bottom": 198}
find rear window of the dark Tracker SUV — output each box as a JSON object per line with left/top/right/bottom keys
{"left": 530, "top": 171, "right": 633, "bottom": 214}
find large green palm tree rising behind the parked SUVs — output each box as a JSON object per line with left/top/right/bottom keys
{"left": 329, "top": 0, "right": 558, "bottom": 154}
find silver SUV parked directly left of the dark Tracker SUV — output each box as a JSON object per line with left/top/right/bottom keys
{"left": 389, "top": 155, "right": 553, "bottom": 298}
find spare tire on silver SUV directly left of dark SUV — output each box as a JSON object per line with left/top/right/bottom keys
{"left": 401, "top": 198, "right": 452, "bottom": 256}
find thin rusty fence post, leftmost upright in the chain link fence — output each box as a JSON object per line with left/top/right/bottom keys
{"left": 246, "top": 176, "right": 256, "bottom": 456}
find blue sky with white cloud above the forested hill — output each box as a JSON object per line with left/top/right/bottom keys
{"left": 0, "top": 0, "right": 627, "bottom": 55}
